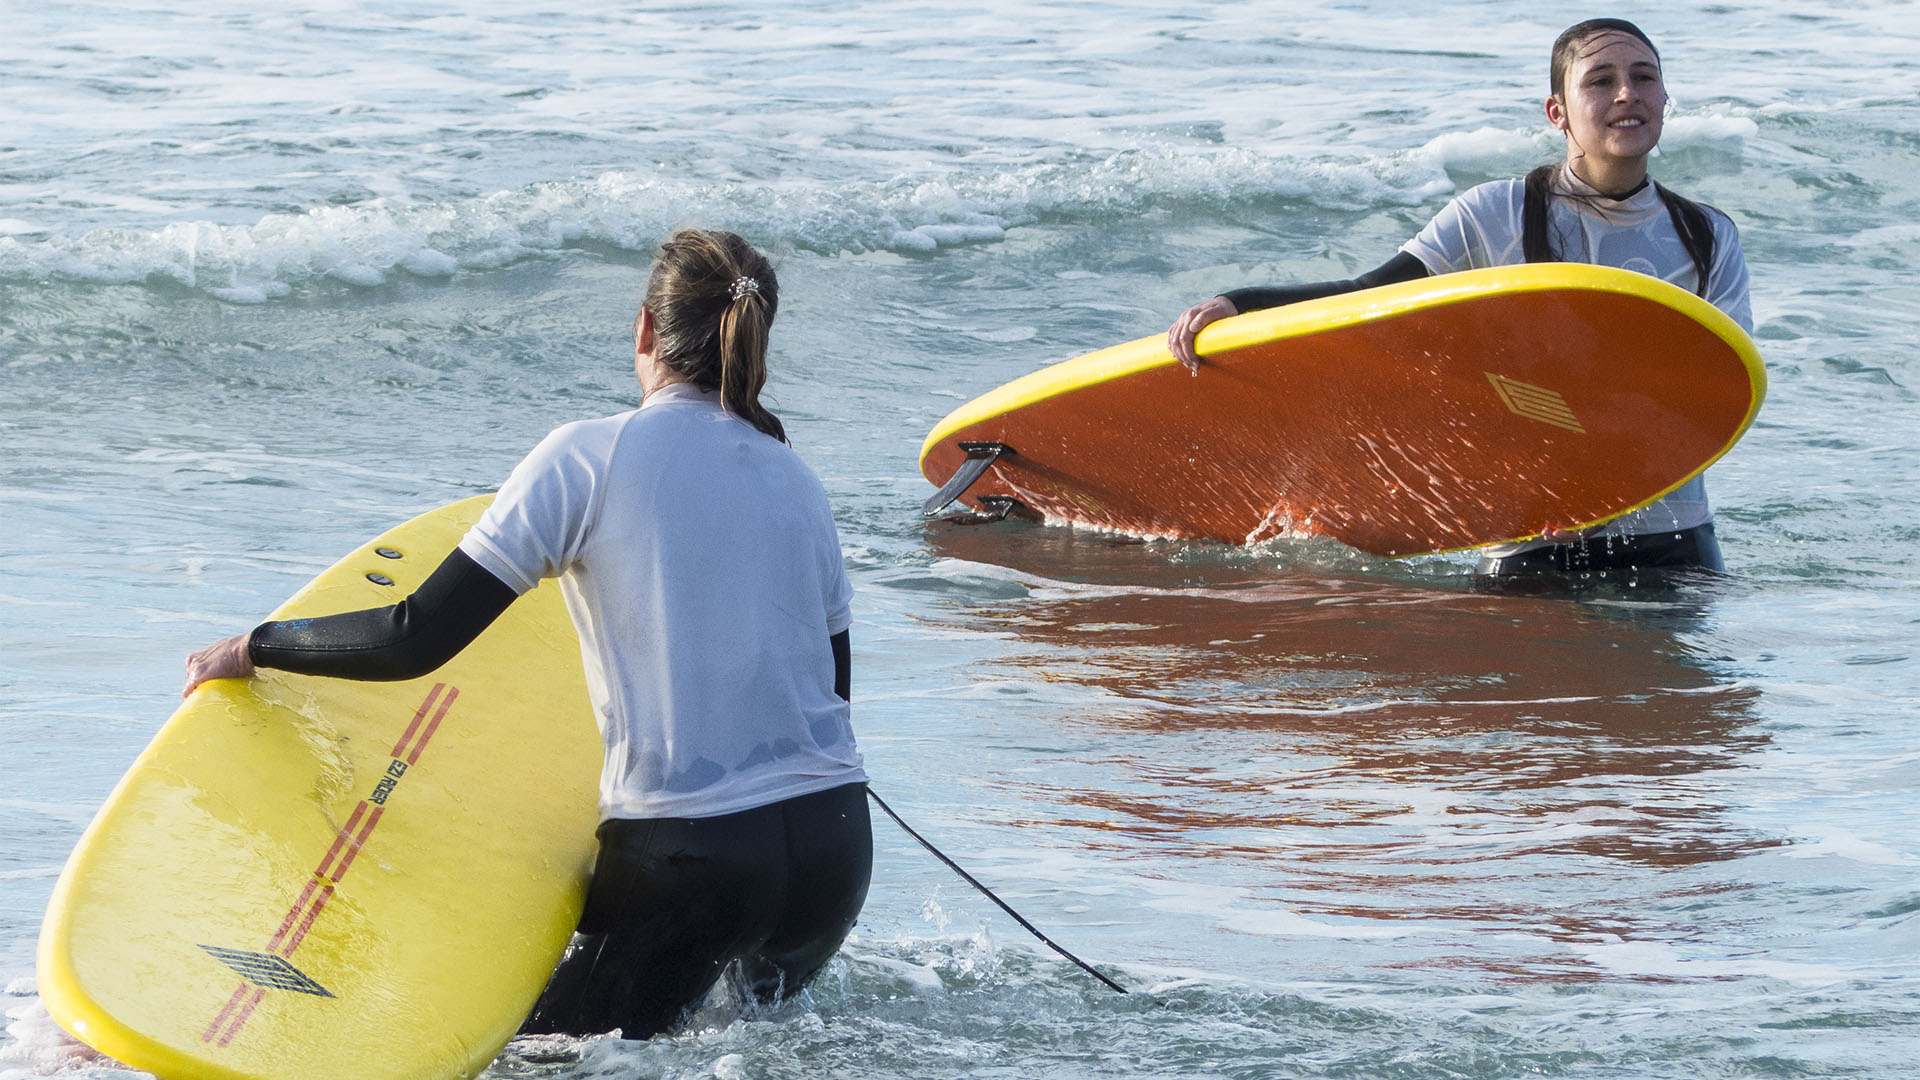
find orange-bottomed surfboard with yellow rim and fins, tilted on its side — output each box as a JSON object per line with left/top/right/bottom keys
{"left": 920, "top": 263, "right": 1766, "bottom": 555}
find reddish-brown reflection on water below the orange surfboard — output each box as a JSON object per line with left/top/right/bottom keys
{"left": 929, "top": 527, "right": 1774, "bottom": 976}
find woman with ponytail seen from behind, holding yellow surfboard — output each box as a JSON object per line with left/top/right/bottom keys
{"left": 186, "top": 229, "right": 874, "bottom": 1038}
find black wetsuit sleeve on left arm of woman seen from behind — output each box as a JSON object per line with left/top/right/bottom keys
{"left": 248, "top": 548, "right": 518, "bottom": 680}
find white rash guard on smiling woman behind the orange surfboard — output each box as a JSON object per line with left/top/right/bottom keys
{"left": 1402, "top": 169, "right": 1753, "bottom": 557}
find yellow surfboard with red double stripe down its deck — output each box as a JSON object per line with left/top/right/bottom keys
{"left": 38, "top": 496, "right": 601, "bottom": 1080}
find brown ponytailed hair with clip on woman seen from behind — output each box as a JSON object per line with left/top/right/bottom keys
{"left": 641, "top": 229, "right": 787, "bottom": 442}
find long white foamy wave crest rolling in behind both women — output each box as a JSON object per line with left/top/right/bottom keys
{"left": 0, "top": 148, "right": 1452, "bottom": 304}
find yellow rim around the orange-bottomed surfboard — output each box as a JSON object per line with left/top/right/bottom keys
{"left": 920, "top": 263, "right": 1766, "bottom": 553}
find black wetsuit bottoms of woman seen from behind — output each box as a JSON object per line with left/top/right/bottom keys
{"left": 522, "top": 784, "right": 874, "bottom": 1040}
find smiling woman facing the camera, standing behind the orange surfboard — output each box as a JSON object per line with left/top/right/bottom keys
{"left": 1167, "top": 19, "right": 1753, "bottom": 575}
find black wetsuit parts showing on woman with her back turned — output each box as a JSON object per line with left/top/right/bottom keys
{"left": 248, "top": 548, "right": 874, "bottom": 1038}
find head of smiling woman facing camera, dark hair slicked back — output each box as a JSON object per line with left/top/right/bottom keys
{"left": 1548, "top": 31, "right": 1667, "bottom": 165}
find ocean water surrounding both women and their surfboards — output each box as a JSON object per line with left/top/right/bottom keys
{"left": 0, "top": 0, "right": 1920, "bottom": 1080}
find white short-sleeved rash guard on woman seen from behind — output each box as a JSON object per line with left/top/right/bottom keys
{"left": 461, "top": 382, "right": 866, "bottom": 819}
